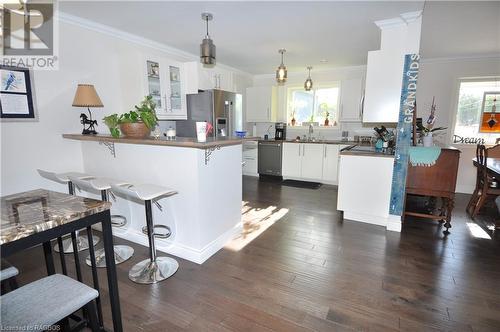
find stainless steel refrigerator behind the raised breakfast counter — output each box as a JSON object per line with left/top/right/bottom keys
{"left": 176, "top": 90, "right": 243, "bottom": 137}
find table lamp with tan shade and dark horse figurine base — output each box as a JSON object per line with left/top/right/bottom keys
{"left": 73, "top": 84, "right": 104, "bottom": 135}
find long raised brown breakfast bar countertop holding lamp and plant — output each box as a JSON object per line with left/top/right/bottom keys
{"left": 62, "top": 134, "right": 259, "bottom": 149}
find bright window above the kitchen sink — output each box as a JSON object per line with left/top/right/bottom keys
{"left": 287, "top": 84, "right": 339, "bottom": 126}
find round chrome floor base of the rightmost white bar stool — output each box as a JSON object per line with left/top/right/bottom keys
{"left": 128, "top": 257, "right": 179, "bottom": 284}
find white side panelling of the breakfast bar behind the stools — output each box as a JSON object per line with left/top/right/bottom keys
{"left": 82, "top": 141, "right": 241, "bottom": 263}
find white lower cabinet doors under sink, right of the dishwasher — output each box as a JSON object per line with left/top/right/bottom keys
{"left": 282, "top": 143, "right": 346, "bottom": 184}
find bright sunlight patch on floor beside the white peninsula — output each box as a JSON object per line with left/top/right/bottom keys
{"left": 224, "top": 201, "right": 289, "bottom": 251}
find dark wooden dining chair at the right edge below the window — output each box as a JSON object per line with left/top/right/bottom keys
{"left": 471, "top": 145, "right": 500, "bottom": 219}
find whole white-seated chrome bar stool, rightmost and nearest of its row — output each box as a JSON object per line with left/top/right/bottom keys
{"left": 111, "top": 184, "right": 179, "bottom": 284}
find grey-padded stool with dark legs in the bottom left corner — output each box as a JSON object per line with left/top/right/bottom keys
{"left": 0, "top": 274, "right": 100, "bottom": 332}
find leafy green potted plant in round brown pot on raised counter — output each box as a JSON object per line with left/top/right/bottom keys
{"left": 103, "top": 96, "right": 158, "bottom": 138}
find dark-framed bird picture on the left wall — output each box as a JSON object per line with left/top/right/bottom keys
{"left": 0, "top": 65, "right": 37, "bottom": 121}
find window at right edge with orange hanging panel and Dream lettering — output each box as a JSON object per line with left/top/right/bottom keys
{"left": 452, "top": 79, "right": 500, "bottom": 144}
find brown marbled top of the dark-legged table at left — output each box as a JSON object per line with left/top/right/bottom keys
{"left": 0, "top": 189, "right": 111, "bottom": 244}
